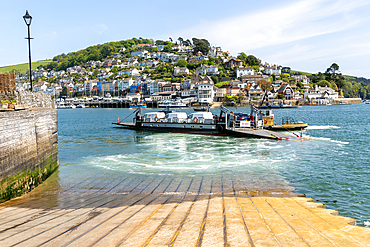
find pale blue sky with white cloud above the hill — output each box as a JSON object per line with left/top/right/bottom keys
{"left": 0, "top": 0, "right": 370, "bottom": 78}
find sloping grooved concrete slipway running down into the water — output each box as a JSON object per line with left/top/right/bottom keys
{"left": 0, "top": 175, "right": 370, "bottom": 246}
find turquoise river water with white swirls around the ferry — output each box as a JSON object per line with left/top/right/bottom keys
{"left": 58, "top": 104, "right": 370, "bottom": 226}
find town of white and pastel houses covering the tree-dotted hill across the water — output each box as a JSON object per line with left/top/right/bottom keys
{"left": 10, "top": 38, "right": 360, "bottom": 104}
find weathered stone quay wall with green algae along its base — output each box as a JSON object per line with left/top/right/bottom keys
{"left": 0, "top": 107, "right": 59, "bottom": 202}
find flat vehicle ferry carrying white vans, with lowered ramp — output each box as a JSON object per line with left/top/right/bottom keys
{"left": 112, "top": 106, "right": 304, "bottom": 140}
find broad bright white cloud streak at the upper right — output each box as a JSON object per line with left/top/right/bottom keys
{"left": 178, "top": 0, "right": 369, "bottom": 54}
